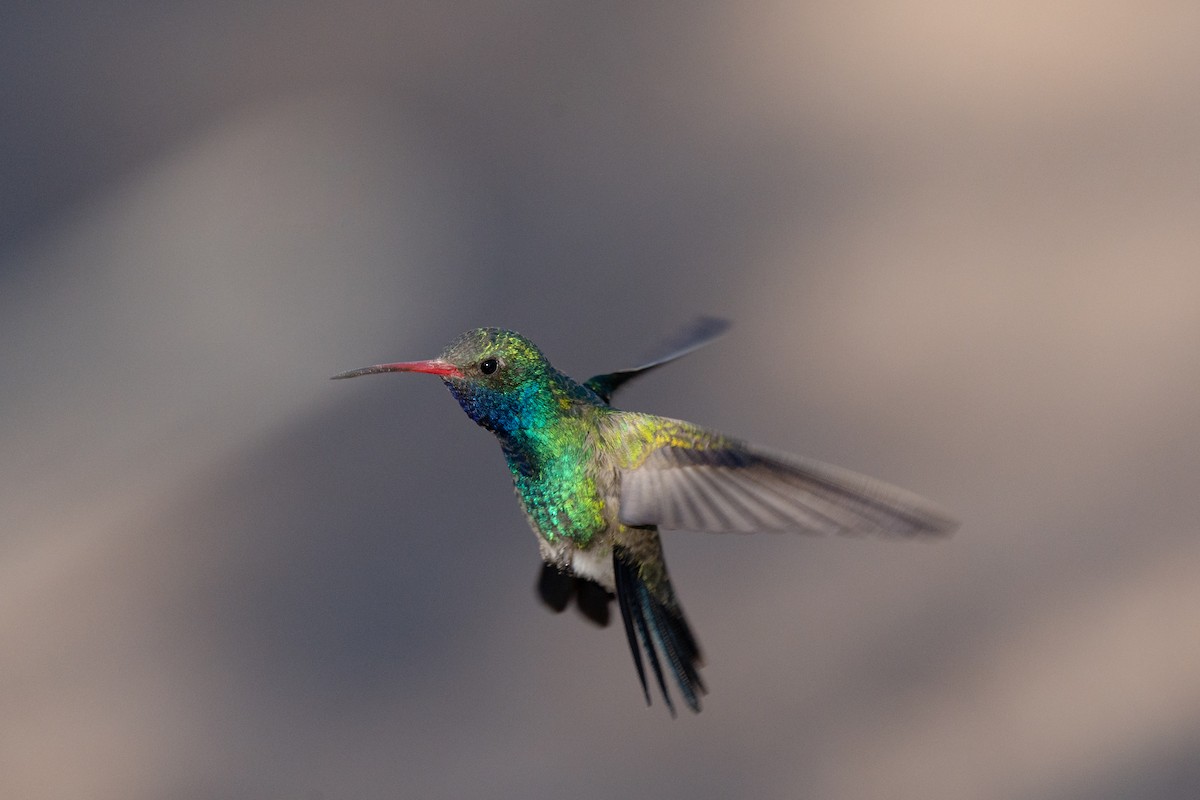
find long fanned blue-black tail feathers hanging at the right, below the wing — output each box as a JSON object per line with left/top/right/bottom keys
{"left": 612, "top": 547, "right": 704, "bottom": 716}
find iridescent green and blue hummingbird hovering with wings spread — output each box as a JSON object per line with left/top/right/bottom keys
{"left": 334, "top": 318, "right": 958, "bottom": 716}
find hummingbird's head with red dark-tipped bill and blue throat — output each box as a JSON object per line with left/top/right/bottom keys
{"left": 334, "top": 327, "right": 569, "bottom": 435}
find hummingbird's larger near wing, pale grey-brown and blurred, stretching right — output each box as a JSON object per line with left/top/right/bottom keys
{"left": 620, "top": 443, "right": 958, "bottom": 536}
